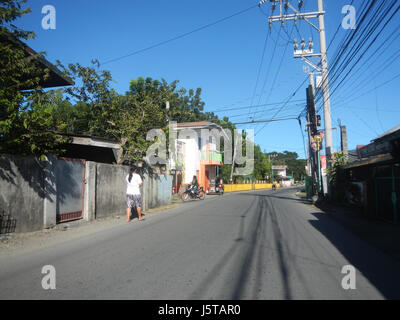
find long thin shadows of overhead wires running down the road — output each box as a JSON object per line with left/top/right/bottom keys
{"left": 191, "top": 193, "right": 294, "bottom": 300}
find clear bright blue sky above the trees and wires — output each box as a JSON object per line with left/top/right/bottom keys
{"left": 14, "top": 0, "right": 400, "bottom": 158}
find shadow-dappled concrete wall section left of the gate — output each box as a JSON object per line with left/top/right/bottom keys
{"left": 0, "top": 155, "right": 45, "bottom": 232}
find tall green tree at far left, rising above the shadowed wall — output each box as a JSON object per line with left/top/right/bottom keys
{"left": 0, "top": 0, "right": 64, "bottom": 159}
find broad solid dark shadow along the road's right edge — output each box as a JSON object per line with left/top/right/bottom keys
{"left": 309, "top": 212, "right": 400, "bottom": 299}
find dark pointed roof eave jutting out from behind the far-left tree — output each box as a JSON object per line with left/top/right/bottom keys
{"left": 0, "top": 31, "right": 74, "bottom": 90}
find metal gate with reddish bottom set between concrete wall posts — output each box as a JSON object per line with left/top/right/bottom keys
{"left": 55, "top": 158, "right": 86, "bottom": 223}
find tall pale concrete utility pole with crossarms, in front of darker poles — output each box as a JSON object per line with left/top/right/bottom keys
{"left": 259, "top": 0, "right": 333, "bottom": 193}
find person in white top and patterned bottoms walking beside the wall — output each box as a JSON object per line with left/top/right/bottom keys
{"left": 126, "top": 166, "right": 144, "bottom": 222}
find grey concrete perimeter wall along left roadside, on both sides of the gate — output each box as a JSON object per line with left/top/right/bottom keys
{"left": 0, "top": 155, "right": 172, "bottom": 232}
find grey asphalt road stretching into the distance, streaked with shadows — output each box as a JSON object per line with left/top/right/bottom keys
{"left": 0, "top": 189, "right": 400, "bottom": 300}
